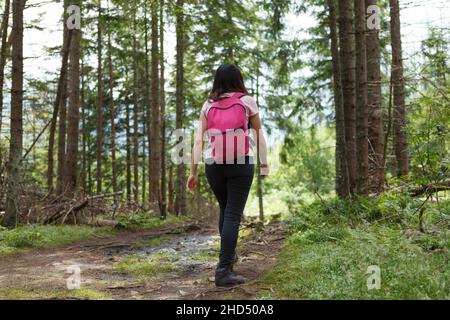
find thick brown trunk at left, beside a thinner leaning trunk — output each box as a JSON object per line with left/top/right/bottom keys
{"left": 64, "top": 9, "right": 81, "bottom": 196}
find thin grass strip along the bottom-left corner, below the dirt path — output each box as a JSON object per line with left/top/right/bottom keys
{"left": 0, "top": 288, "right": 111, "bottom": 300}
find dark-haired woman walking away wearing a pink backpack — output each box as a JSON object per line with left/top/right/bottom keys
{"left": 187, "top": 64, "right": 268, "bottom": 287}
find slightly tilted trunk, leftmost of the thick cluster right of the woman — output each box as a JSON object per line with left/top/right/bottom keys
{"left": 327, "top": 0, "right": 350, "bottom": 198}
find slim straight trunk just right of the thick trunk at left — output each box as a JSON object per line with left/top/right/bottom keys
{"left": 95, "top": 1, "right": 103, "bottom": 194}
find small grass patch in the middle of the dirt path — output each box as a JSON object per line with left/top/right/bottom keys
{"left": 113, "top": 254, "right": 174, "bottom": 279}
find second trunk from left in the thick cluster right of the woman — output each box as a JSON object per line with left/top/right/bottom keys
{"left": 339, "top": 0, "right": 357, "bottom": 194}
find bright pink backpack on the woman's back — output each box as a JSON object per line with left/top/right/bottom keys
{"left": 206, "top": 92, "right": 249, "bottom": 164}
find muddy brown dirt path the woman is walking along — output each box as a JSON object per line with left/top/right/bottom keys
{"left": 0, "top": 223, "right": 285, "bottom": 299}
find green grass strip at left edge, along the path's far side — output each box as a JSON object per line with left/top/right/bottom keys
{"left": 0, "top": 225, "right": 115, "bottom": 255}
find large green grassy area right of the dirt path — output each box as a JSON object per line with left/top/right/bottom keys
{"left": 260, "top": 197, "right": 450, "bottom": 299}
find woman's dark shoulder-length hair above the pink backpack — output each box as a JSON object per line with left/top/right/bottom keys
{"left": 209, "top": 64, "right": 248, "bottom": 101}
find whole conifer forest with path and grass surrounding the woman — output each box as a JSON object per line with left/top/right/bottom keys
{"left": 0, "top": 0, "right": 450, "bottom": 300}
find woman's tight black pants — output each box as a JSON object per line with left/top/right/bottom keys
{"left": 206, "top": 157, "right": 255, "bottom": 269}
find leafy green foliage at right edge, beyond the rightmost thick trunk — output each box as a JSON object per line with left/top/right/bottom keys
{"left": 408, "top": 28, "right": 450, "bottom": 184}
